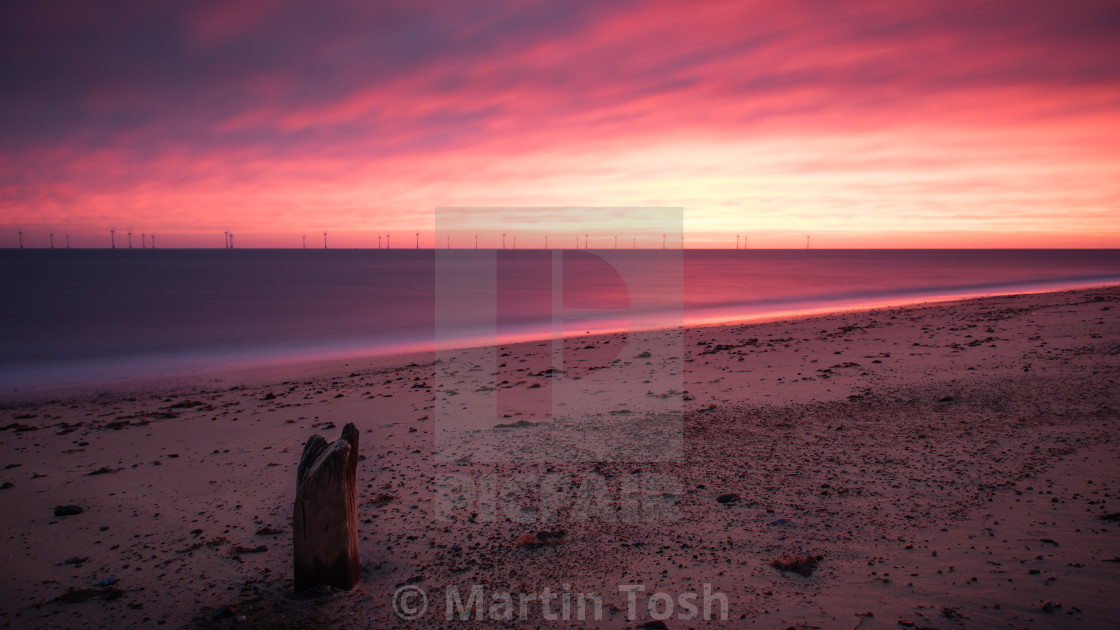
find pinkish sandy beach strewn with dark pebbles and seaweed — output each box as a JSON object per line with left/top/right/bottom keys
{"left": 0, "top": 286, "right": 1120, "bottom": 629}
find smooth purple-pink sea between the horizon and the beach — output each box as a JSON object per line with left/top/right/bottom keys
{"left": 0, "top": 250, "right": 1120, "bottom": 390}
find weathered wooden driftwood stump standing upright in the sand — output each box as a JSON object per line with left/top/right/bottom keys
{"left": 292, "top": 424, "right": 361, "bottom": 591}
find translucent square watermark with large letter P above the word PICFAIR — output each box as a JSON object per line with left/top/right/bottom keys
{"left": 433, "top": 207, "right": 684, "bottom": 463}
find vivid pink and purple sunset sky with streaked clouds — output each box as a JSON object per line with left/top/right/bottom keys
{"left": 0, "top": 0, "right": 1120, "bottom": 248}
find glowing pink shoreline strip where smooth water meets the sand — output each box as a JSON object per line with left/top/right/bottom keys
{"left": 0, "top": 281, "right": 1120, "bottom": 406}
